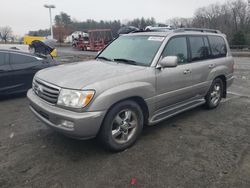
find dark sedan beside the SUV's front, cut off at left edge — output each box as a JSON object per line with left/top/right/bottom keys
{"left": 0, "top": 49, "right": 56, "bottom": 96}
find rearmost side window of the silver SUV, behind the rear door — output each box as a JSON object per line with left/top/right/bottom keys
{"left": 208, "top": 36, "right": 227, "bottom": 58}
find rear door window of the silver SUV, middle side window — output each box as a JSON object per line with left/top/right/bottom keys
{"left": 189, "top": 36, "right": 210, "bottom": 61}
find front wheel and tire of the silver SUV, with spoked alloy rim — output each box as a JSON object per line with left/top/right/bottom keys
{"left": 98, "top": 100, "right": 143, "bottom": 152}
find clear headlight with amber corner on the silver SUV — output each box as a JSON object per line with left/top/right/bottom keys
{"left": 57, "top": 89, "right": 95, "bottom": 108}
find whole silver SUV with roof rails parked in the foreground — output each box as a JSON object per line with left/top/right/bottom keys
{"left": 27, "top": 29, "right": 234, "bottom": 151}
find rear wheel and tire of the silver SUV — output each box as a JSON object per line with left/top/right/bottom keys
{"left": 205, "top": 78, "right": 224, "bottom": 109}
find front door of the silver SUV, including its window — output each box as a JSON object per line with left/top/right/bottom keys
{"left": 156, "top": 36, "right": 194, "bottom": 110}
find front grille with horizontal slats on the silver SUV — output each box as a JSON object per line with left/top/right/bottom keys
{"left": 32, "top": 79, "right": 60, "bottom": 104}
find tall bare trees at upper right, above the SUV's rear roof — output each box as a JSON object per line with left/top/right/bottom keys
{"left": 193, "top": 0, "right": 250, "bottom": 41}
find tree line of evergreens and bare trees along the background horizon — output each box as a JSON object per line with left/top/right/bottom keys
{"left": 26, "top": 0, "right": 250, "bottom": 45}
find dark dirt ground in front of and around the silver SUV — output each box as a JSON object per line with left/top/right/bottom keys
{"left": 0, "top": 58, "right": 250, "bottom": 188}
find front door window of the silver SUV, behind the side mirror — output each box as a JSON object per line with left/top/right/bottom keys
{"left": 162, "top": 37, "right": 188, "bottom": 64}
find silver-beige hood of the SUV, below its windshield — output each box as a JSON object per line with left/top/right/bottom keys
{"left": 36, "top": 60, "right": 146, "bottom": 89}
